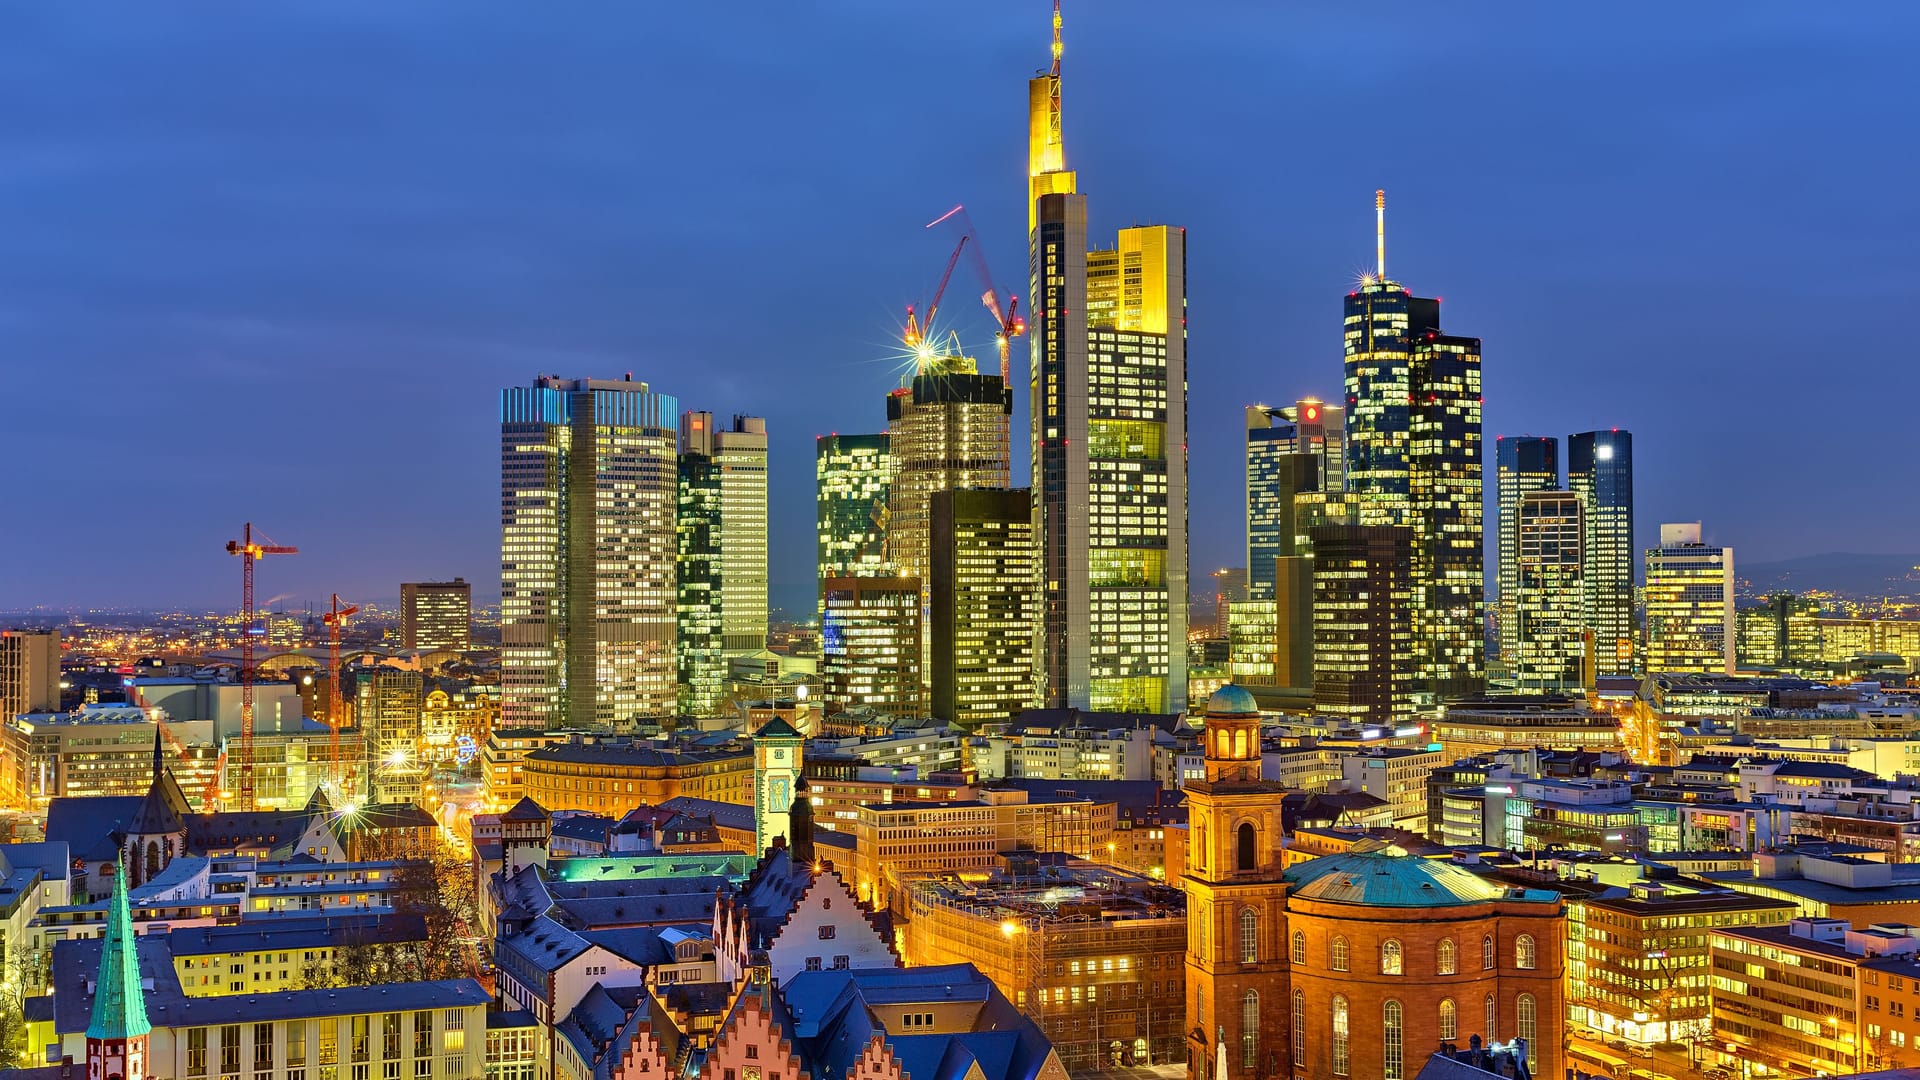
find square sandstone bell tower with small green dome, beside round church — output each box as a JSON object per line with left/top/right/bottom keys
{"left": 1181, "top": 686, "right": 1292, "bottom": 1080}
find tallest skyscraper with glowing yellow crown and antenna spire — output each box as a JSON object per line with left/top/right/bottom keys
{"left": 1027, "top": 13, "right": 1187, "bottom": 713}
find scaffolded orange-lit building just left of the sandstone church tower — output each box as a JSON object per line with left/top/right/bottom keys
{"left": 902, "top": 853, "right": 1187, "bottom": 1072}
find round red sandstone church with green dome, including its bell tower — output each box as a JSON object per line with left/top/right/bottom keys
{"left": 1181, "top": 686, "right": 1567, "bottom": 1080}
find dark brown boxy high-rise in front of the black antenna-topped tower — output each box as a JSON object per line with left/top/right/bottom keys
{"left": 1311, "top": 525, "right": 1413, "bottom": 724}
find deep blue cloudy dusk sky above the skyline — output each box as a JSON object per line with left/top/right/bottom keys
{"left": 0, "top": 0, "right": 1920, "bottom": 607}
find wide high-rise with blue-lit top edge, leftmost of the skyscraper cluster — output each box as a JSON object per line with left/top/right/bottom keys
{"left": 499, "top": 377, "right": 680, "bottom": 730}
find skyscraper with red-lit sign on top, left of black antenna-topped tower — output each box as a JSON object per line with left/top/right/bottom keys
{"left": 1246, "top": 398, "right": 1346, "bottom": 600}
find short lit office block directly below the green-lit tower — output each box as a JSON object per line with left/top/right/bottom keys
{"left": 820, "top": 578, "right": 922, "bottom": 717}
